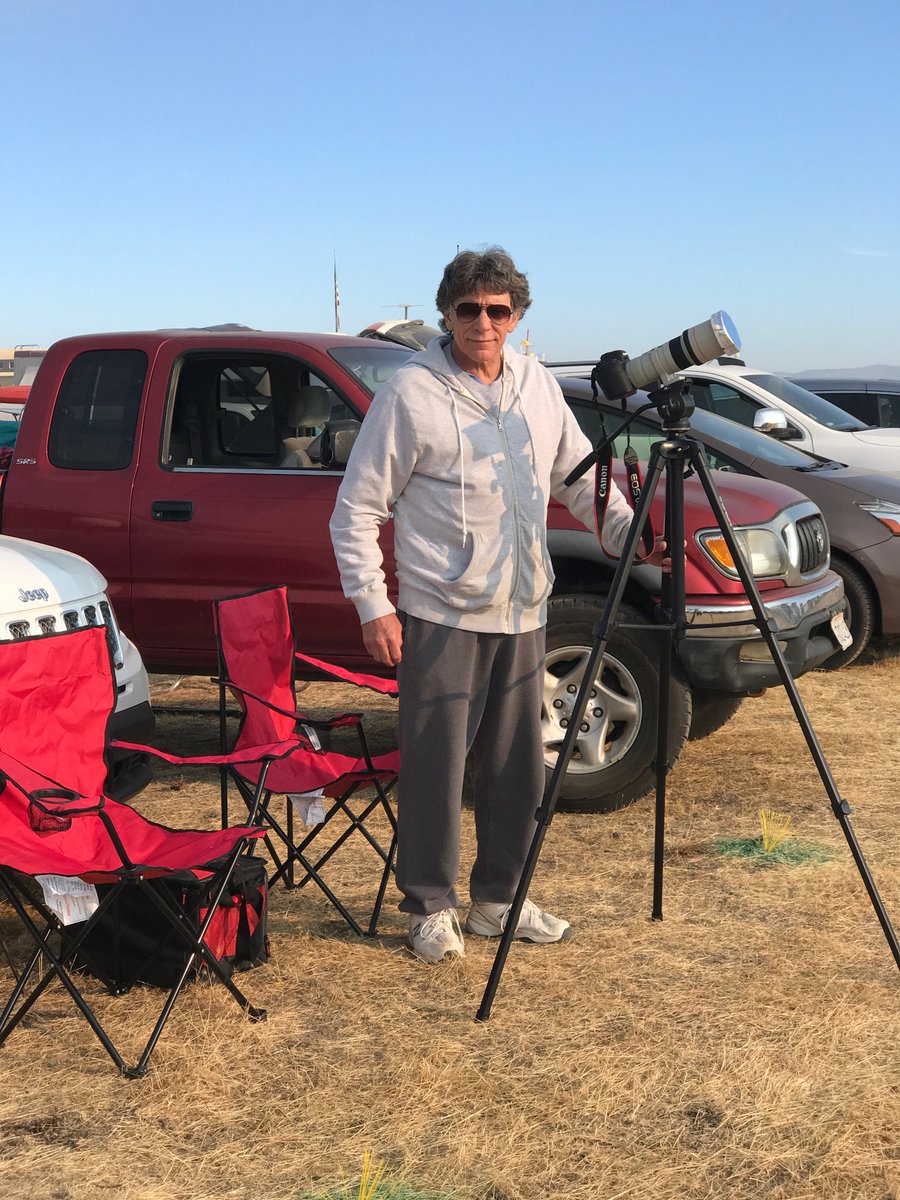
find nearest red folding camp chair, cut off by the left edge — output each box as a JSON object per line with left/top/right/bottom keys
{"left": 0, "top": 626, "right": 266, "bottom": 1078}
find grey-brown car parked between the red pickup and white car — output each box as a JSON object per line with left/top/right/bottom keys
{"left": 559, "top": 378, "right": 900, "bottom": 668}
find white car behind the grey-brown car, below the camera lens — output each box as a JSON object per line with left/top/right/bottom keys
{"left": 680, "top": 361, "right": 900, "bottom": 475}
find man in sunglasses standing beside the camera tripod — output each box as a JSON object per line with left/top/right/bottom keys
{"left": 331, "top": 247, "right": 648, "bottom": 962}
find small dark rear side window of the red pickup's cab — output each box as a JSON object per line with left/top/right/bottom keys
{"left": 47, "top": 350, "right": 148, "bottom": 470}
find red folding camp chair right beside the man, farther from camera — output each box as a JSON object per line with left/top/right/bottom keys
{"left": 215, "top": 587, "right": 400, "bottom": 936}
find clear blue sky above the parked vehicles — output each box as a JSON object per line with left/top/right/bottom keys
{"left": 7, "top": 0, "right": 900, "bottom": 371}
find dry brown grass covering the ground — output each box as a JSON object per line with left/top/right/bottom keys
{"left": 0, "top": 655, "right": 900, "bottom": 1200}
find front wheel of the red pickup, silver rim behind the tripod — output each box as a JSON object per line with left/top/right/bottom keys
{"left": 541, "top": 595, "right": 691, "bottom": 812}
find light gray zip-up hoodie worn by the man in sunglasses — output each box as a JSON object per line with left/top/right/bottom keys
{"left": 330, "top": 338, "right": 632, "bottom": 634}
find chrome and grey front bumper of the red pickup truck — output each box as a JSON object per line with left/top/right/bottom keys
{"left": 677, "top": 571, "right": 844, "bottom": 695}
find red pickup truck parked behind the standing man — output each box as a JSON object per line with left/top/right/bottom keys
{"left": 0, "top": 329, "right": 844, "bottom": 810}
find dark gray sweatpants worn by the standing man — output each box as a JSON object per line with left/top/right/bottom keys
{"left": 397, "top": 616, "right": 545, "bottom": 913}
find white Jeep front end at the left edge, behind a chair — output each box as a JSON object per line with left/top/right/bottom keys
{"left": 0, "top": 535, "right": 154, "bottom": 800}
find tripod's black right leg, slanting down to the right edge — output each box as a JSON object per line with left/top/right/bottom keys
{"left": 690, "top": 443, "right": 900, "bottom": 967}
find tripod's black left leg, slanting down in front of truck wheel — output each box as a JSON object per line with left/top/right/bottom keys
{"left": 475, "top": 448, "right": 664, "bottom": 1021}
